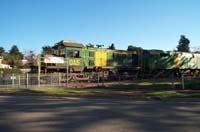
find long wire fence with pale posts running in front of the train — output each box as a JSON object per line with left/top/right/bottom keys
{"left": 0, "top": 73, "right": 200, "bottom": 89}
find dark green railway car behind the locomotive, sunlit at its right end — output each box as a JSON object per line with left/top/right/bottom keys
{"left": 140, "top": 50, "right": 200, "bottom": 77}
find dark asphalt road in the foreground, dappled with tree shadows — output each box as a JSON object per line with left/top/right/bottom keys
{"left": 0, "top": 96, "right": 200, "bottom": 132}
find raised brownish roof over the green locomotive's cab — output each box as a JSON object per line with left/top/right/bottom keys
{"left": 53, "top": 40, "right": 84, "bottom": 48}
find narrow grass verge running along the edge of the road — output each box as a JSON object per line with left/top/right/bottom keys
{"left": 0, "top": 88, "right": 200, "bottom": 99}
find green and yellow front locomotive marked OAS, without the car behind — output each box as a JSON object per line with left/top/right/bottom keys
{"left": 41, "top": 40, "right": 137, "bottom": 79}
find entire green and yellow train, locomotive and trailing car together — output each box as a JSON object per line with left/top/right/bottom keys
{"left": 41, "top": 40, "right": 200, "bottom": 78}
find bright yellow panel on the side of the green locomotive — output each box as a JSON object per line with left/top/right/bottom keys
{"left": 95, "top": 51, "right": 107, "bottom": 66}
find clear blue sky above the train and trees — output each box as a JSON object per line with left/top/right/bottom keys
{"left": 0, "top": 0, "right": 200, "bottom": 54}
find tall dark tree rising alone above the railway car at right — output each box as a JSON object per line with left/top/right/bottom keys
{"left": 177, "top": 35, "right": 190, "bottom": 52}
